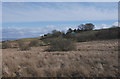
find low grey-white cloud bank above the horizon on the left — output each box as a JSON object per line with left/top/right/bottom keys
{"left": 2, "top": 25, "right": 81, "bottom": 38}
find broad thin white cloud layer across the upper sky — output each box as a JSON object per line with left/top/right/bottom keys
{"left": 3, "top": 3, "right": 118, "bottom": 22}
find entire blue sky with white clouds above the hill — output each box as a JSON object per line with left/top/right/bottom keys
{"left": 2, "top": 2, "right": 118, "bottom": 38}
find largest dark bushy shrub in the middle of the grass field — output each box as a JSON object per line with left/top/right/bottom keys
{"left": 48, "top": 38, "right": 75, "bottom": 51}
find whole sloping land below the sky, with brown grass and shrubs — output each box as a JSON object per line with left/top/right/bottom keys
{"left": 2, "top": 27, "right": 120, "bottom": 77}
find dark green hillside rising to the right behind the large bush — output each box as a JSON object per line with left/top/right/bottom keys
{"left": 41, "top": 27, "right": 120, "bottom": 42}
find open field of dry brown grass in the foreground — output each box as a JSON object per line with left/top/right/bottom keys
{"left": 2, "top": 39, "right": 119, "bottom": 77}
